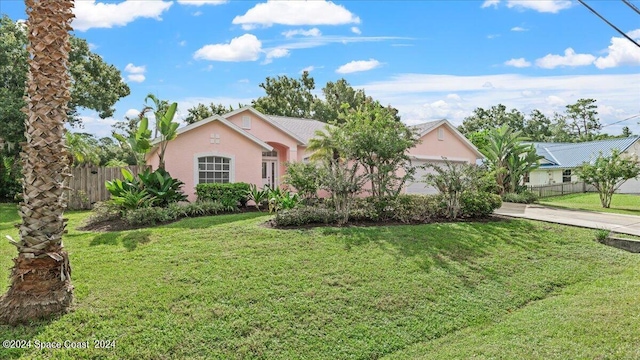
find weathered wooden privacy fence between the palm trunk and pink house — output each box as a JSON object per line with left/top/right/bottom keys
{"left": 65, "top": 165, "right": 148, "bottom": 210}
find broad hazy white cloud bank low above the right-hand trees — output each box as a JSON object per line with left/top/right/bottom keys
{"left": 354, "top": 73, "right": 640, "bottom": 133}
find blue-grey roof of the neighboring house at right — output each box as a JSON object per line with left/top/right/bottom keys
{"left": 531, "top": 136, "right": 638, "bottom": 169}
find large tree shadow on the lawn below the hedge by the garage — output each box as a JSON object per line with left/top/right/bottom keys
{"left": 320, "top": 220, "right": 542, "bottom": 284}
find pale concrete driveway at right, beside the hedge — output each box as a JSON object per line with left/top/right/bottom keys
{"left": 494, "top": 203, "right": 640, "bottom": 236}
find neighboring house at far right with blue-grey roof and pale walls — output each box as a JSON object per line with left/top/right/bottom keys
{"left": 525, "top": 136, "right": 640, "bottom": 193}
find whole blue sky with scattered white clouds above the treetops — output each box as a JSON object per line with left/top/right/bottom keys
{"left": 0, "top": 0, "right": 640, "bottom": 136}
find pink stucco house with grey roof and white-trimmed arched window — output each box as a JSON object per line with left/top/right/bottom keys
{"left": 147, "top": 107, "right": 482, "bottom": 201}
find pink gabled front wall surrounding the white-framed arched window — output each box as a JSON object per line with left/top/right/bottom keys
{"left": 147, "top": 121, "right": 262, "bottom": 201}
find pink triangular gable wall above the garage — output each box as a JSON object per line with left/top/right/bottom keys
{"left": 409, "top": 125, "right": 478, "bottom": 164}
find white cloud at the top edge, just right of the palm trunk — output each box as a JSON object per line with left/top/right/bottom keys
{"left": 72, "top": 0, "right": 173, "bottom": 31}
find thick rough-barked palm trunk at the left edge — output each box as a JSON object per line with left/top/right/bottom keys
{"left": 0, "top": 0, "right": 73, "bottom": 324}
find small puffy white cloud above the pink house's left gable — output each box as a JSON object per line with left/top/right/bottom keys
{"left": 193, "top": 34, "right": 262, "bottom": 61}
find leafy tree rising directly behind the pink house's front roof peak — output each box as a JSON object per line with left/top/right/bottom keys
{"left": 251, "top": 71, "right": 318, "bottom": 118}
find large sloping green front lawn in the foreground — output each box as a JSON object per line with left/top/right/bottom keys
{"left": 0, "top": 205, "right": 640, "bottom": 359}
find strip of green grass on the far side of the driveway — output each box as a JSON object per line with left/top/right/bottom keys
{"left": 540, "top": 193, "right": 640, "bottom": 215}
